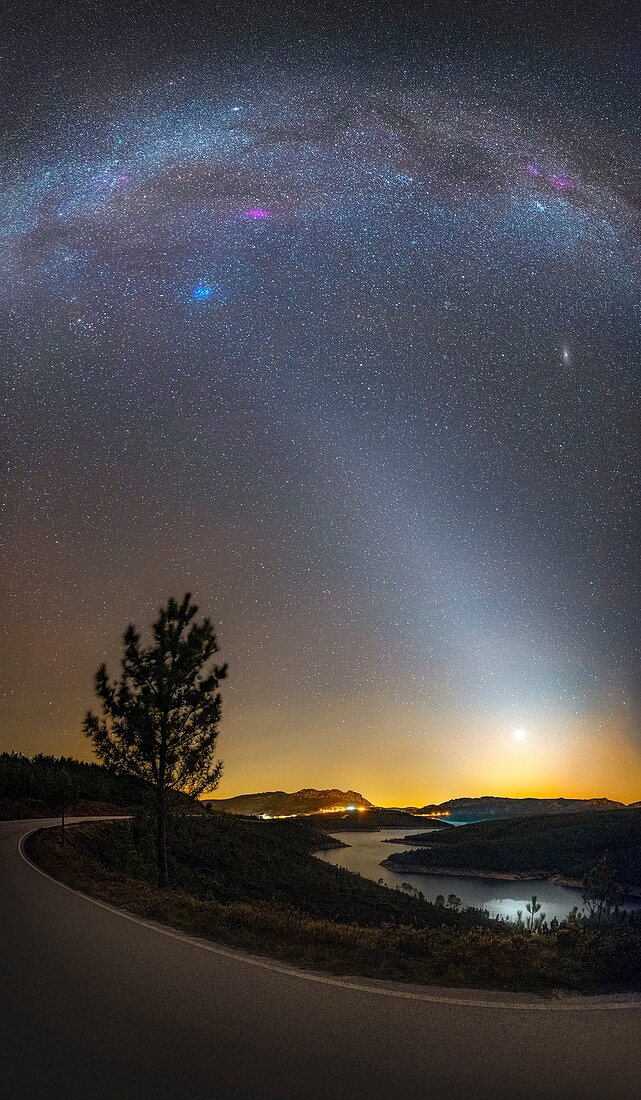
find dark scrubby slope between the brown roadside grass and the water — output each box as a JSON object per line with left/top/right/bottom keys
{"left": 35, "top": 813, "right": 482, "bottom": 926}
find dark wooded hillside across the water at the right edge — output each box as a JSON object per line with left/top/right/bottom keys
{"left": 385, "top": 810, "right": 641, "bottom": 892}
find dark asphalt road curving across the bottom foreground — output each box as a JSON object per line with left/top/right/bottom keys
{"left": 0, "top": 822, "right": 641, "bottom": 1100}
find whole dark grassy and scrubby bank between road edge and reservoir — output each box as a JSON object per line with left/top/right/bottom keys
{"left": 29, "top": 814, "right": 641, "bottom": 991}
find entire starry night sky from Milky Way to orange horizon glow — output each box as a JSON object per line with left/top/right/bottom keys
{"left": 0, "top": 2, "right": 641, "bottom": 804}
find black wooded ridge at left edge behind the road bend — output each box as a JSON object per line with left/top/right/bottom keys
{"left": 0, "top": 752, "right": 144, "bottom": 807}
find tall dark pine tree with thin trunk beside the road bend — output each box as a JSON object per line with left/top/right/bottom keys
{"left": 84, "top": 593, "right": 226, "bottom": 887}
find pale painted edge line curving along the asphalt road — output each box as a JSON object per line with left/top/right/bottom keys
{"left": 18, "top": 818, "right": 641, "bottom": 1012}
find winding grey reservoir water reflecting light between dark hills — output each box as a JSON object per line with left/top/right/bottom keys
{"left": 318, "top": 828, "right": 641, "bottom": 921}
